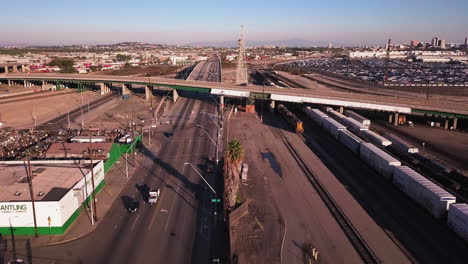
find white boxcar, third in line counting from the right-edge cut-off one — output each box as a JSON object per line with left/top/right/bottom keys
{"left": 359, "top": 142, "right": 401, "bottom": 179}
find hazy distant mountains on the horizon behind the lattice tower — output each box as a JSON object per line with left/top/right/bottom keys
{"left": 187, "top": 38, "right": 328, "bottom": 48}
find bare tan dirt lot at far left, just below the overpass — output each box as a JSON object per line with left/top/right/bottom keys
{"left": 0, "top": 89, "right": 100, "bottom": 129}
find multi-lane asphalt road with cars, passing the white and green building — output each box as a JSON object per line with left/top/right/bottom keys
{"left": 24, "top": 94, "right": 222, "bottom": 264}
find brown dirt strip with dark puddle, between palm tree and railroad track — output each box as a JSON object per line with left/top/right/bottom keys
{"left": 228, "top": 113, "right": 361, "bottom": 263}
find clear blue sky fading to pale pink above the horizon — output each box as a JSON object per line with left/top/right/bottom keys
{"left": 0, "top": 0, "right": 468, "bottom": 45}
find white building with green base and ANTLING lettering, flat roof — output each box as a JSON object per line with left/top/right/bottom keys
{"left": 0, "top": 161, "right": 104, "bottom": 235}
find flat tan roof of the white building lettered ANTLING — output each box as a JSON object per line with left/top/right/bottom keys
{"left": 0, "top": 164, "right": 89, "bottom": 202}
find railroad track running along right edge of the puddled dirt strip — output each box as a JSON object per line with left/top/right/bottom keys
{"left": 274, "top": 128, "right": 380, "bottom": 264}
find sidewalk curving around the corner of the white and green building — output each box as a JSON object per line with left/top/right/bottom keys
{"left": 3, "top": 154, "right": 150, "bottom": 253}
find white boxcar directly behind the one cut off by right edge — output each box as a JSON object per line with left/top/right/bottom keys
{"left": 393, "top": 166, "right": 456, "bottom": 218}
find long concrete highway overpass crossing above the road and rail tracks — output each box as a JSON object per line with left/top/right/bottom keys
{"left": 0, "top": 73, "right": 468, "bottom": 118}
